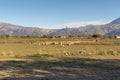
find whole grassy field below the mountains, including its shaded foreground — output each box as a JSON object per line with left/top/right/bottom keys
{"left": 0, "top": 37, "right": 120, "bottom": 80}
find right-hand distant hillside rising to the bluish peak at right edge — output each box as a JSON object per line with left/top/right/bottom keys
{"left": 50, "top": 18, "right": 120, "bottom": 36}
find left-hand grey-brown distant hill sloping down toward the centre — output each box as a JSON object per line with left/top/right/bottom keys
{"left": 0, "top": 23, "right": 53, "bottom": 36}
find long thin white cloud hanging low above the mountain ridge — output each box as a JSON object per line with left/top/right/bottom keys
{"left": 49, "top": 20, "right": 109, "bottom": 29}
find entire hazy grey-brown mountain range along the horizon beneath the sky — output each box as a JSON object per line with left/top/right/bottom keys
{"left": 0, "top": 18, "right": 120, "bottom": 36}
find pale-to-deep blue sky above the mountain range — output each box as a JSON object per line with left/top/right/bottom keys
{"left": 0, "top": 0, "right": 120, "bottom": 28}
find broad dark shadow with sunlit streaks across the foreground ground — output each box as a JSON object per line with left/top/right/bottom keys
{"left": 0, "top": 58, "right": 120, "bottom": 80}
